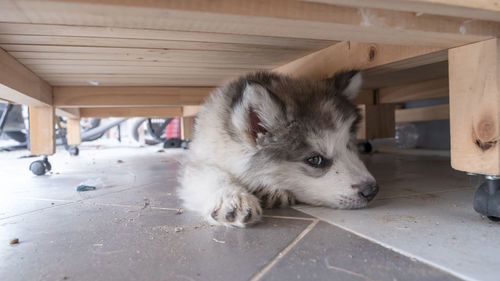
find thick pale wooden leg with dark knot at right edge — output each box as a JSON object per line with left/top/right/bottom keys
{"left": 449, "top": 39, "right": 500, "bottom": 175}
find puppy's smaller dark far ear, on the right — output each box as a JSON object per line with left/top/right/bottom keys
{"left": 327, "top": 70, "right": 363, "bottom": 100}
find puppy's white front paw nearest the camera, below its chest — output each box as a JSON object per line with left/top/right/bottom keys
{"left": 210, "top": 192, "right": 262, "bottom": 227}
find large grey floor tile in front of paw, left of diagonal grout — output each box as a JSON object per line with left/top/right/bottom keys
{"left": 0, "top": 200, "right": 311, "bottom": 281}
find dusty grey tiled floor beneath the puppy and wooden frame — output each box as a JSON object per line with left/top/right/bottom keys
{"left": 0, "top": 144, "right": 494, "bottom": 281}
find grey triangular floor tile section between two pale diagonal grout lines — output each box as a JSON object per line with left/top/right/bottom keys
{"left": 261, "top": 222, "right": 460, "bottom": 281}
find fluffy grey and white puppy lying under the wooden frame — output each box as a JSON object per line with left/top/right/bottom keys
{"left": 179, "top": 71, "right": 378, "bottom": 227}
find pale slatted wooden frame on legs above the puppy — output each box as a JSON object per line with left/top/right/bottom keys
{"left": 0, "top": 0, "right": 500, "bottom": 175}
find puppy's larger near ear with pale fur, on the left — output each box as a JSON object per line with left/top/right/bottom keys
{"left": 232, "top": 81, "right": 285, "bottom": 144}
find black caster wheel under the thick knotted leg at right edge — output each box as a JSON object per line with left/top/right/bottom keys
{"left": 474, "top": 176, "right": 500, "bottom": 222}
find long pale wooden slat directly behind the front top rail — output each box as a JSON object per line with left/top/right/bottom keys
{"left": 0, "top": 22, "right": 335, "bottom": 50}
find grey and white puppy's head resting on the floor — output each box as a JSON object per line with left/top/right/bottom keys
{"left": 229, "top": 71, "right": 378, "bottom": 209}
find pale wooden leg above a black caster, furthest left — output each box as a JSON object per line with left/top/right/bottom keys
{"left": 29, "top": 106, "right": 56, "bottom": 155}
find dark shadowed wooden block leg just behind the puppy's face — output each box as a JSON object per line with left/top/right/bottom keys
{"left": 356, "top": 104, "right": 395, "bottom": 140}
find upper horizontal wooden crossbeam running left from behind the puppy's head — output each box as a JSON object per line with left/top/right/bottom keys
{"left": 54, "top": 86, "right": 213, "bottom": 108}
